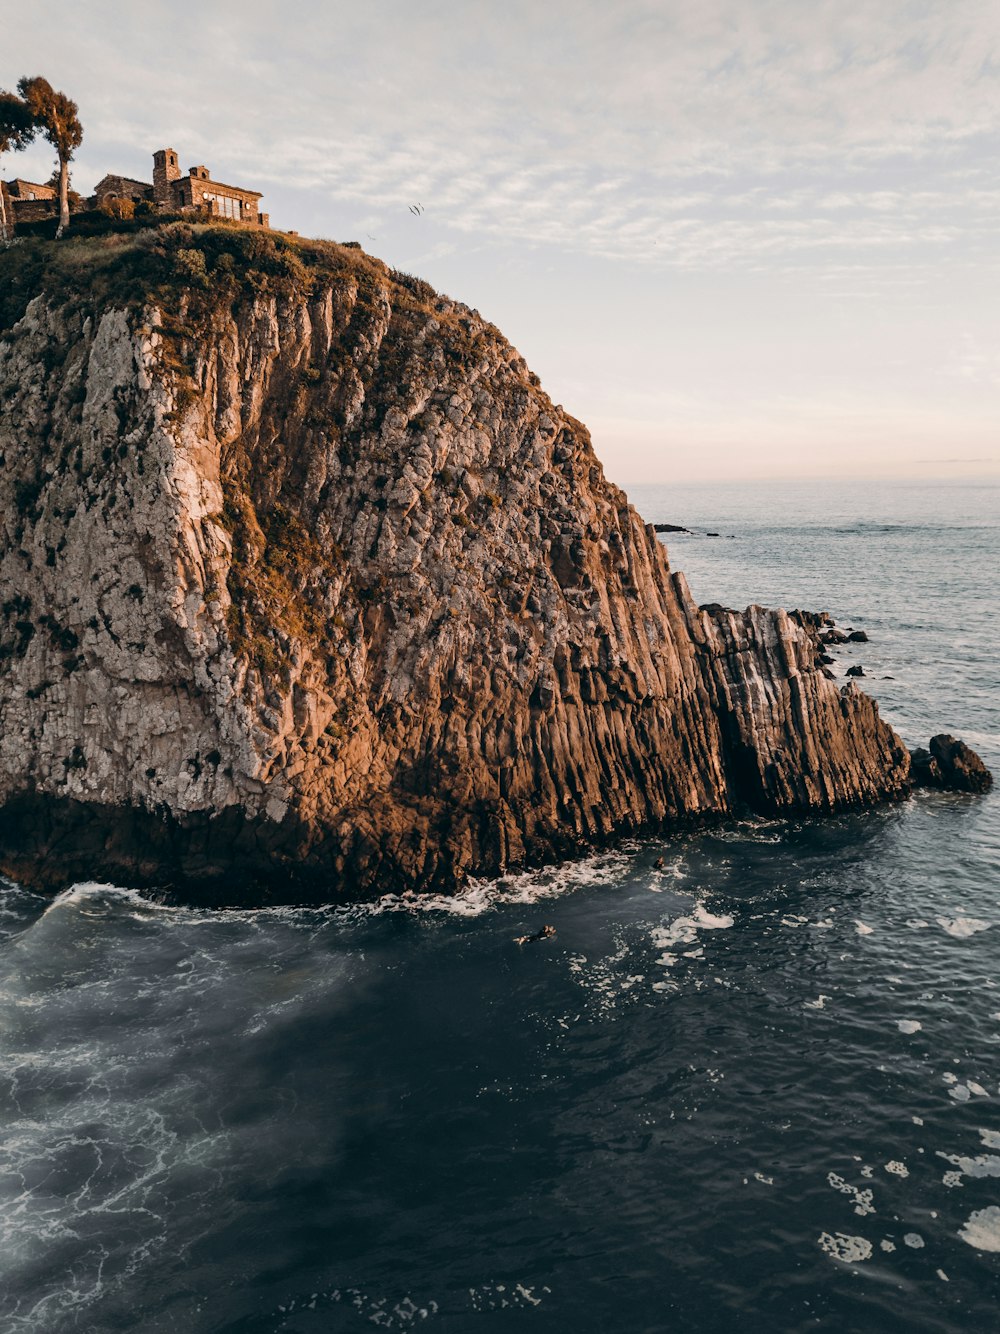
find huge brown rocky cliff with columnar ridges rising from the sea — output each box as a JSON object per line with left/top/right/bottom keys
{"left": 0, "top": 228, "right": 938, "bottom": 902}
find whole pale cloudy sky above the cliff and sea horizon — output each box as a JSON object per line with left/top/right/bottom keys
{"left": 0, "top": 0, "right": 1000, "bottom": 486}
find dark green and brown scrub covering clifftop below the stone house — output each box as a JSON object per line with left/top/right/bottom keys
{"left": 0, "top": 215, "right": 440, "bottom": 338}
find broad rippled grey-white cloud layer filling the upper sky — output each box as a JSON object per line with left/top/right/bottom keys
{"left": 8, "top": 0, "right": 1000, "bottom": 268}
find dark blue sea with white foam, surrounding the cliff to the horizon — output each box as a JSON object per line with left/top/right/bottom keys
{"left": 0, "top": 474, "right": 1000, "bottom": 1334}
